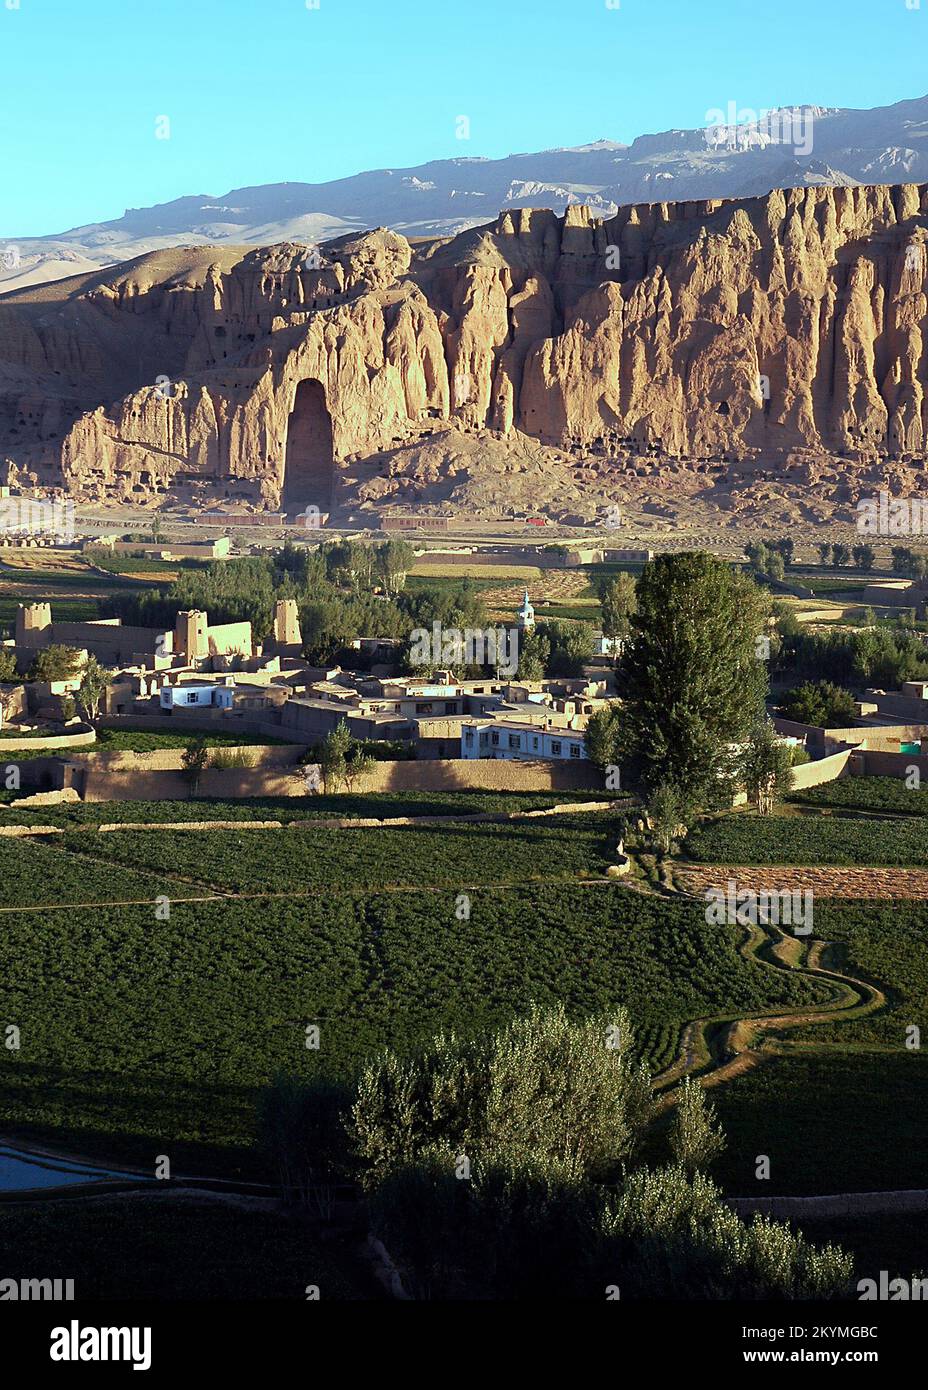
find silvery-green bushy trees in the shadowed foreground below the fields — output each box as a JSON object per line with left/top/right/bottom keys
{"left": 261, "top": 1005, "right": 853, "bottom": 1300}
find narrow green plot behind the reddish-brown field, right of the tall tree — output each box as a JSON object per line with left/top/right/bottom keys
{"left": 683, "top": 815, "right": 928, "bottom": 867}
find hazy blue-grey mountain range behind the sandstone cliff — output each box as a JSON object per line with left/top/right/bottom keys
{"left": 0, "top": 97, "right": 928, "bottom": 289}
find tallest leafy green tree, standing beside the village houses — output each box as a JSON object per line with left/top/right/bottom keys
{"left": 618, "top": 553, "right": 767, "bottom": 806}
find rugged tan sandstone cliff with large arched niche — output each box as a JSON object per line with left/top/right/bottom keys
{"left": 0, "top": 185, "right": 928, "bottom": 510}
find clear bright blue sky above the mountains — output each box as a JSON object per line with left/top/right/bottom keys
{"left": 0, "top": 0, "right": 928, "bottom": 236}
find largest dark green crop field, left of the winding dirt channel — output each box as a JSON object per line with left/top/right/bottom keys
{"left": 0, "top": 884, "right": 825, "bottom": 1176}
